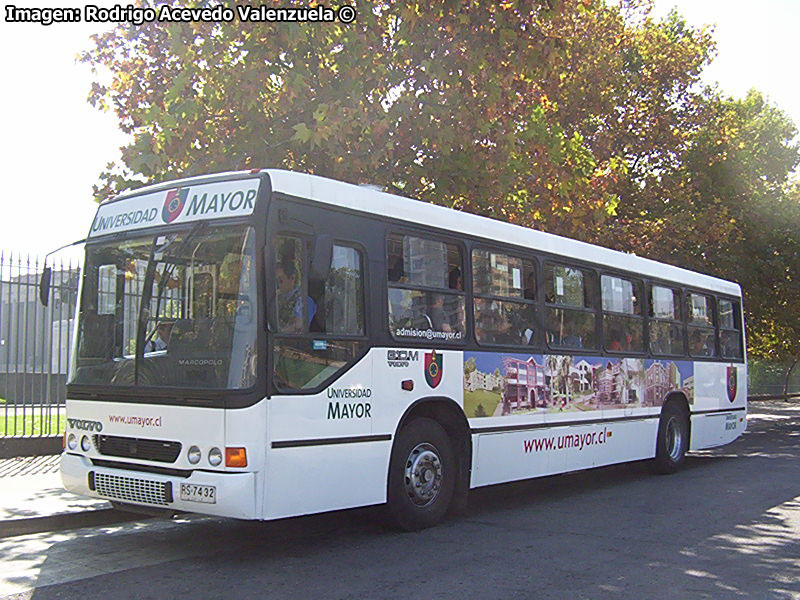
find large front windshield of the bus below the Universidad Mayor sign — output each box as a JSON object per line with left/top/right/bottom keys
{"left": 70, "top": 222, "right": 257, "bottom": 389}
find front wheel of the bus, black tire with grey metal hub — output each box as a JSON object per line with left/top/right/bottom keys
{"left": 387, "top": 418, "right": 458, "bottom": 531}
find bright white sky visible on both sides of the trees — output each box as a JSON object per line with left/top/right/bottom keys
{"left": 0, "top": 0, "right": 800, "bottom": 256}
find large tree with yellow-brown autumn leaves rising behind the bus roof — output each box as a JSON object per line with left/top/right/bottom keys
{"left": 83, "top": 0, "right": 710, "bottom": 239}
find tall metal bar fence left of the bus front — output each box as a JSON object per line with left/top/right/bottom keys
{"left": 0, "top": 252, "right": 80, "bottom": 438}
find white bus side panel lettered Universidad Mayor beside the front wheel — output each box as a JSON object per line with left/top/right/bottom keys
{"left": 264, "top": 348, "right": 463, "bottom": 519}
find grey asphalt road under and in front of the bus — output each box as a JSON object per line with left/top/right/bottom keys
{"left": 0, "top": 402, "right": 800, "bottom": 600}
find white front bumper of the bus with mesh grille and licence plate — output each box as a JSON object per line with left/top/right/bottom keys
{"left": 61, "top": 453, "right": 257, "bottom": 519}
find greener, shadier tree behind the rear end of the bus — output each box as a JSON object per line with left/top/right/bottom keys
{"left": 612, "top": 90, "right": 800, "bottom": 360}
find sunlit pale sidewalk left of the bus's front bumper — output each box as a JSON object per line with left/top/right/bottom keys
{"left": 0, "top": 456, "right": 115, "bottom": 538}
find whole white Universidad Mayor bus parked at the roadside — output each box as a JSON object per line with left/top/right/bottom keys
{"left": 61, "top": 170, "right": 747, "bottom": 529}
